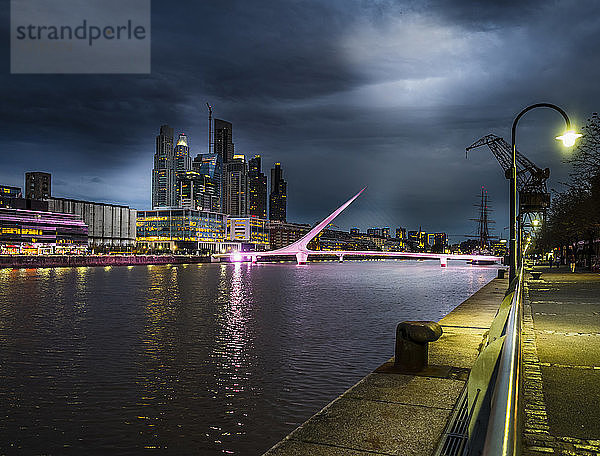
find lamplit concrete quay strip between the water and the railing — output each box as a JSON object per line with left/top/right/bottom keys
{"left": 265, "top": 279, "right": 508, "bottom": 456}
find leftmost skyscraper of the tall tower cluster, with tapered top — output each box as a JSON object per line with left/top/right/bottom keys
{"left": 152, "top": 125, "right": 177, "bottom": 209}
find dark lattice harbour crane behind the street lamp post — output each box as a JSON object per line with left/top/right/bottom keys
{"left": 465, "top": 134, "right": 550, "bottom": 228}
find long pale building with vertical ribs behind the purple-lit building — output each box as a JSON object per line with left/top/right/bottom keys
{"left": 46, "top": 197, "right": 136, "bottom": 249}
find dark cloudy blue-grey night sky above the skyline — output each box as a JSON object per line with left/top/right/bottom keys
{"left": 0, "top": 0, "right": 600, "bottom": 241}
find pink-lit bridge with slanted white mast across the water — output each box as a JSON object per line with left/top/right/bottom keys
{"left": 214, "top": 187, "right": 502, "bottom": 267}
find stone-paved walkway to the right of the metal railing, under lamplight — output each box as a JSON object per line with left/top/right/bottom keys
{"left": 523, "top": 266, "right": 600, "bottom": 455}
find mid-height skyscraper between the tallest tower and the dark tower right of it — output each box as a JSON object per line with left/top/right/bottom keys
{"left": 223, "top": 155, "right": 248, "bottom": 217}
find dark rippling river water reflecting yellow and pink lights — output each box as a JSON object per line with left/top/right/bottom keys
{"left": 0, "top": 261, "right": 496, "bottom": 455}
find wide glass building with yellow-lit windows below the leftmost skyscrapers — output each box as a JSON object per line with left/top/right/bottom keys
{"left": 137, "top": 208, "right": 241, "bottom": 253}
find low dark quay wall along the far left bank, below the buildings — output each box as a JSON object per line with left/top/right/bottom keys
{"left": 0, "top": 255, "right": 210, "bottom": 269}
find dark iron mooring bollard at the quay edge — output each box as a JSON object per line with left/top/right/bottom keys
{"left": 394, "top": 321, "right": 442, "bottom": 372}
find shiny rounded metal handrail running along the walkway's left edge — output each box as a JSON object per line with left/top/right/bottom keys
{"left": 482, "top": 266, "right": 523, "bottom": 456}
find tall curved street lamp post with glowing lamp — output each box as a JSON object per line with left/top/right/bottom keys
{"left": 509, "top": 103, "right": 581, "bottom": 281}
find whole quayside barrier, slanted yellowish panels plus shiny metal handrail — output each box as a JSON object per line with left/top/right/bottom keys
{"left": 435, "top": 267, "right": 524, "bottom": 456}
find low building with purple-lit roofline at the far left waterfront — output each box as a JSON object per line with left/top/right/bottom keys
{"left": 0, "top": 208, "right": 88, "bottom": 254}
